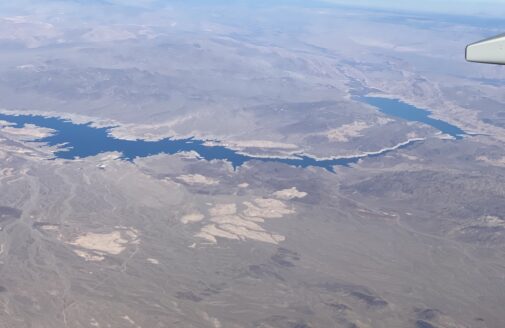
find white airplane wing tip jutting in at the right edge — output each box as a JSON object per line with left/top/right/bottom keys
{"left": 466, "top": 34, "right": 505, "bottom": 65}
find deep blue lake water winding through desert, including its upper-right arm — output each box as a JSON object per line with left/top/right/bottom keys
{"left": 0, "top": 97, "right": 464, "bottom": 172}
